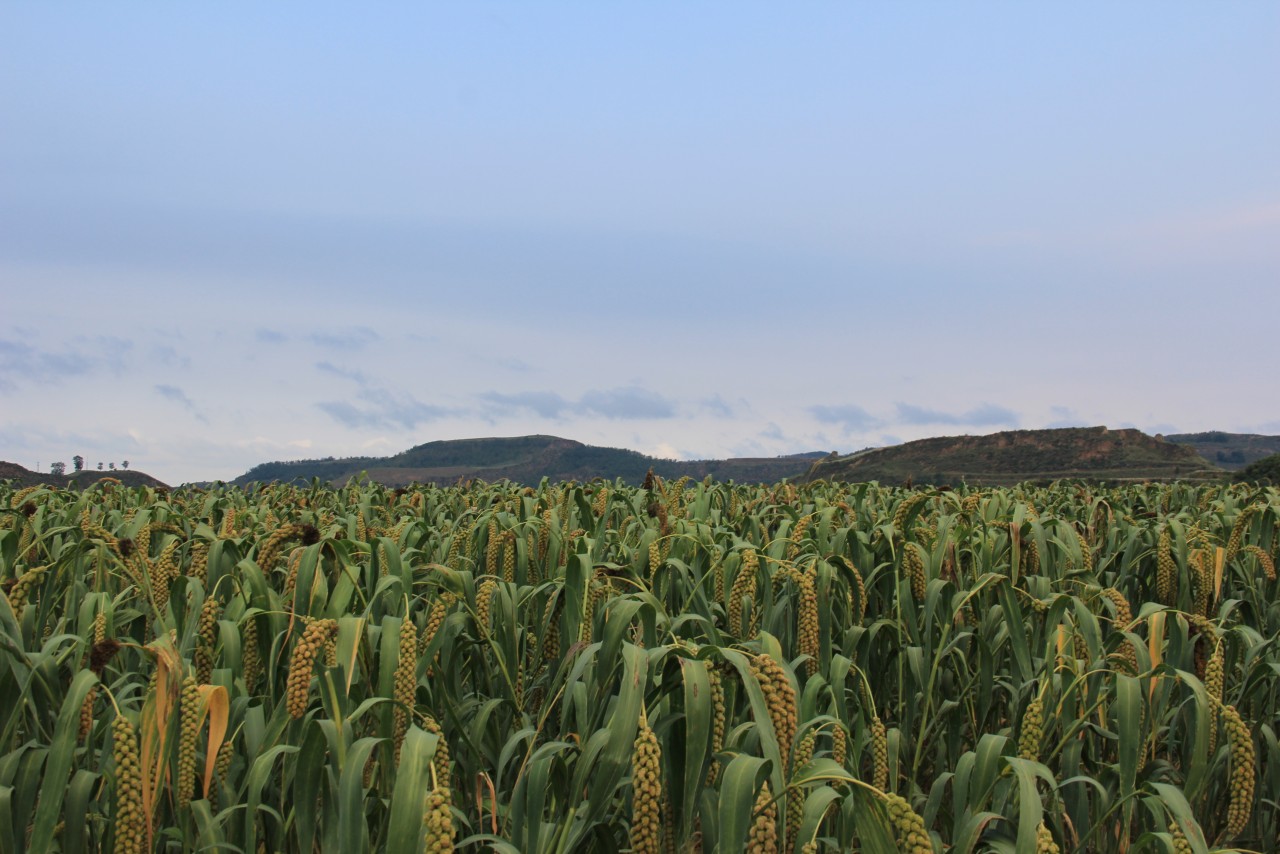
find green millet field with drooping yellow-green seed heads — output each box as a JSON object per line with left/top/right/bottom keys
{"left": 0, "top": 478, "right": 1280, "bottom": 854}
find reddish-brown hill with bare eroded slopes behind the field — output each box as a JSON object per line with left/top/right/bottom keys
{"left": 805, "top": 426, "right": 1221, "bottom": 485}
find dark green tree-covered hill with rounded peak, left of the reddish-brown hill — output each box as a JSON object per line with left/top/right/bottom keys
{"left": 232, "top": 435, "right": 823, "bottom": 487}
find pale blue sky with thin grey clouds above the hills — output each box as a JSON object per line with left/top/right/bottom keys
{"left": 0, "top": 1, "right": 1280, "bottom": 483}
